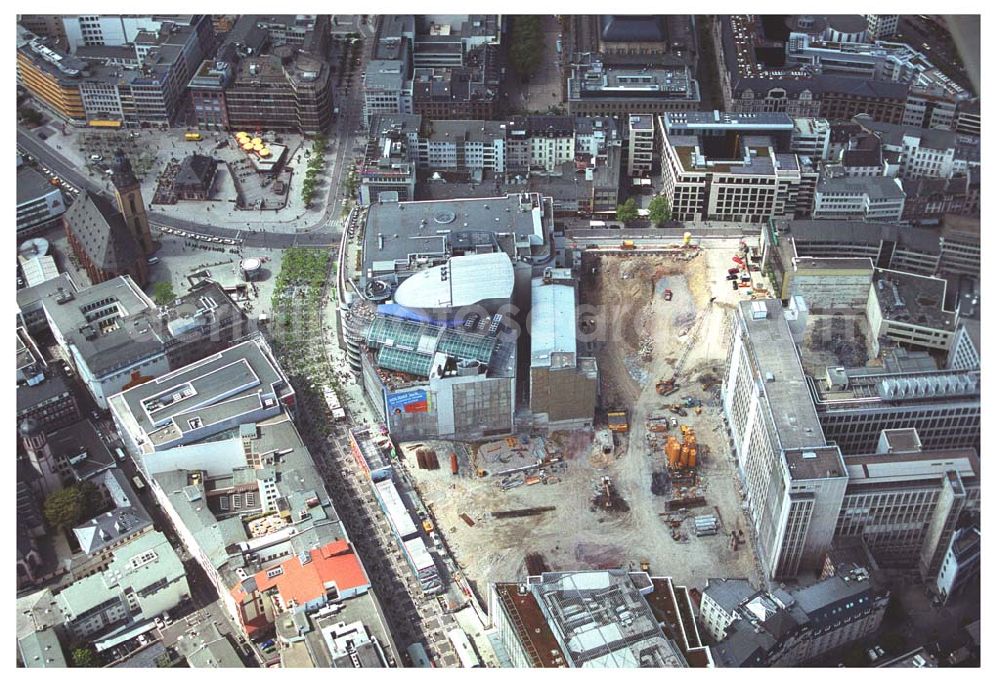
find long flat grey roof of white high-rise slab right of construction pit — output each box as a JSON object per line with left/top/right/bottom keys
{"left": 740, "top": 299, "right": 826, "bottom": 449}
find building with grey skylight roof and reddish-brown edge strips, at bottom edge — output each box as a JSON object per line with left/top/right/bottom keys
{"left": 489, "top": 569, "right": 713, "bottom": 668}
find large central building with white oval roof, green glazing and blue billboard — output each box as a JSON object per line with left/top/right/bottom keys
{"left": 340, "top": 193, "right": 553, "bottom": 438}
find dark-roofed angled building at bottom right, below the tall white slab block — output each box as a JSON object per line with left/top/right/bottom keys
{"left": 701, "top": 567, "right": 889, "bottom": 667}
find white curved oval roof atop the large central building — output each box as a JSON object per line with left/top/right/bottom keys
{"left": 393, "top": 252, "right": 514, "bottom": 308}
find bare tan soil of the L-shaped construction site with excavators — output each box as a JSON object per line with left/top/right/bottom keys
{"left": 403, "top": 240, "right": 759, "bottom": 595}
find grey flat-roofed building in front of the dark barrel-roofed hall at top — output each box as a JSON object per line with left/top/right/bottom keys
{"left": 566, "top": 53, "right": 701, "bottom": 119}
